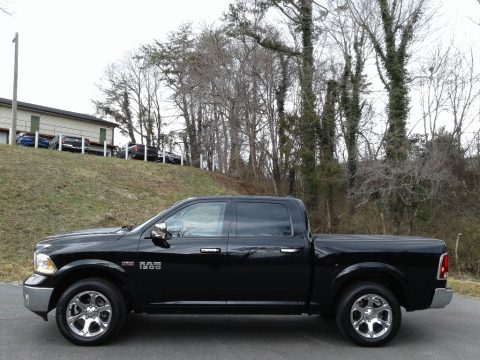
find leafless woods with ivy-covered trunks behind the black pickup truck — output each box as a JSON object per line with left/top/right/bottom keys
{"left": 95, "top": 0, "right": 480, "bottom": 270}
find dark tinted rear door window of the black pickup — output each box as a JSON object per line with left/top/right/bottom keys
{"left": 237, "top": 202, "right": 292, "bottom": 237}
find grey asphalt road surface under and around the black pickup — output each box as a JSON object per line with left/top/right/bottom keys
{"left": 0, "top": 285, "right": 480, "bottom": 360}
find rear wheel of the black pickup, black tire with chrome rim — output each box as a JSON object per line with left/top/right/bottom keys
{"left": 336, "top": 282, "right": 402, "bottom": 347}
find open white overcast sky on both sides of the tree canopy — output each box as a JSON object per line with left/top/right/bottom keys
{"left": 0, "top": 0, "right": 480, "bottom": 146}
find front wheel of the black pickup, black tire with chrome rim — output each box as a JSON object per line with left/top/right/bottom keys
{"left": 56, "top": 278, "right": 126, "bottom": 345}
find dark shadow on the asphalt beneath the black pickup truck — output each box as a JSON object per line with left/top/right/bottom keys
{"left": 32, "top": 314, "right": 432, "bottom": 351}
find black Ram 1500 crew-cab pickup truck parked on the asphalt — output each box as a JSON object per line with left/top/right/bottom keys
{"left": 23, "top": 196, "right": 452, "bottom": 346}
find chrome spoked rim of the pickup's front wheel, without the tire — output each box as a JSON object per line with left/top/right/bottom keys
{"left": 66, "top": 291, "right": 112, "bottom": 337}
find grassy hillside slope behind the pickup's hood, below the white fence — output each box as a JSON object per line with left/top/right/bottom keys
{"left": 0, "top": 145, "right": 242, "bottom": 281}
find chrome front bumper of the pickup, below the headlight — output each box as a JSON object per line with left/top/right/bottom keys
{"left": 23, "top": 274, "right": 53, "bottom": 320}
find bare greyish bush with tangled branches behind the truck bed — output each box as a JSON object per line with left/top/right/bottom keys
{"left": 355, "top": 133, "right": 460, "bottom": 234}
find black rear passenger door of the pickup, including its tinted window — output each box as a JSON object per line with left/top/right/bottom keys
{"left": 227, "top": 200, "right": 309, "bottom": 306}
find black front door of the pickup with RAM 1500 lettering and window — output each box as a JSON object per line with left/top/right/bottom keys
{"left": 137, "top": 201, "right": 229, "bottom": 306}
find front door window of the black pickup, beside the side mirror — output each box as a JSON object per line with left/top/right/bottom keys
{"left": 165, "top": 201, "right": 226, "bottom": 238}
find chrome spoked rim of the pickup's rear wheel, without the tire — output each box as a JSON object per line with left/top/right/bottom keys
{"left": 350, "top": 294, "right": 392, "bottom": 339}
